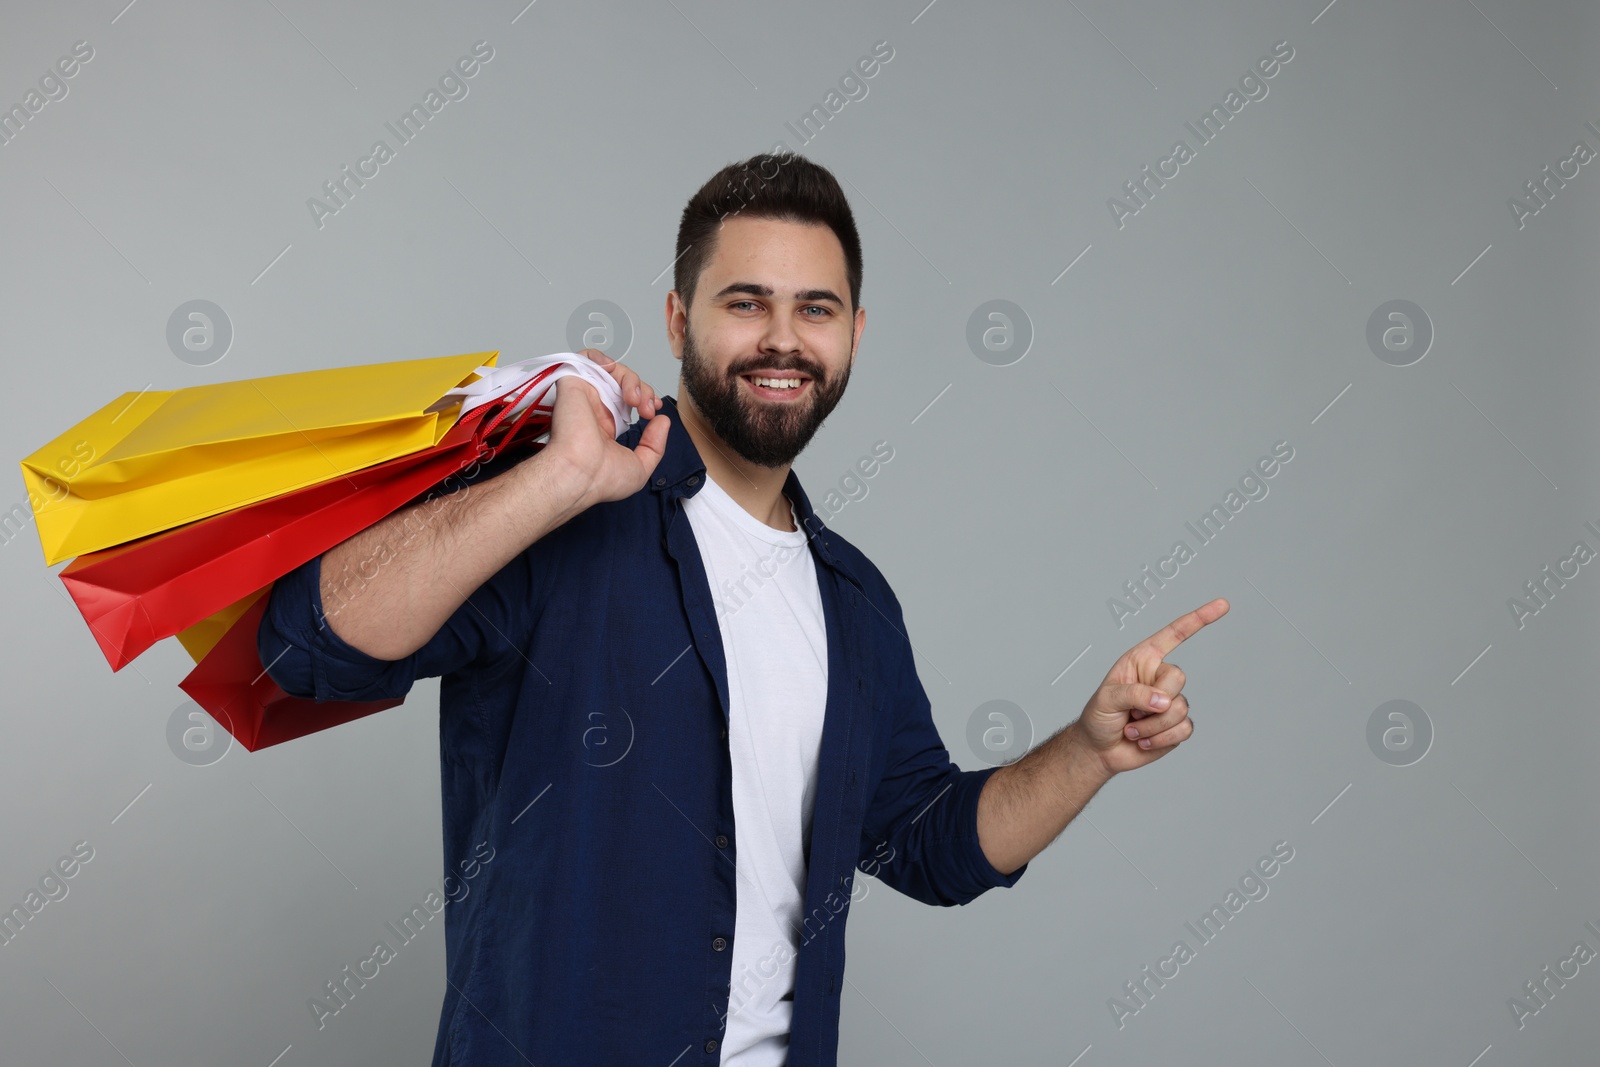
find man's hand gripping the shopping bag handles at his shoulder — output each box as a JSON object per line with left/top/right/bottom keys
{"left": 542, "top": 349, "right": 670, "bottom": 510}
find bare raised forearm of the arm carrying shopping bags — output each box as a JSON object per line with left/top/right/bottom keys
{"left": 320, "top": 451, "right": 586, "bottom": 659}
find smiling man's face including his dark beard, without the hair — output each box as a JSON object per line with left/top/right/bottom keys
{"left": 669, "top": 216, "right": 866, "bottom": 467}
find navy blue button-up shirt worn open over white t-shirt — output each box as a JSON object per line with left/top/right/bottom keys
{"left": 258, "top": 397, "right": 1027, "bottom": 1067}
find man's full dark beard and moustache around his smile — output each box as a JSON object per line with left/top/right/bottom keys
{"left": 683, "top": 316, "right": 850, "bottom": 469}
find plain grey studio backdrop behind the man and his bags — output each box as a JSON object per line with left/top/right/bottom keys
{"left": 0, "top": 0, "right": 1600, "bottom": 1067}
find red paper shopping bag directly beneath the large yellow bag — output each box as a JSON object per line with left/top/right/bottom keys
{"left": 61, "top": 357, "right": 569, "bottom": 670}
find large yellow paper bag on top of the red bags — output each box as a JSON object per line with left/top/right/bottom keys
{"left": 22, "top": 352, "right": 499, "bottom": 565}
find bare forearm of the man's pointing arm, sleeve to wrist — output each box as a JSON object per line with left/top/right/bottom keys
{"left": 978, "top": 723, "right": 1112, "bottom": 875}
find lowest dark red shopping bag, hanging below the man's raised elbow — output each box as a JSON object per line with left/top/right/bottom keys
{"left": 178, "top": 590, "right": 405, "bottom": 752}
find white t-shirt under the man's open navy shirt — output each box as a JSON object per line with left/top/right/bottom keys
{"left": 685, "top": 477, "right": 827, "bottom": 1067}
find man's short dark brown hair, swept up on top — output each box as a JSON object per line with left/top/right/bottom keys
{"left": 672, "top": 150, "right": 861, "bottom": 315}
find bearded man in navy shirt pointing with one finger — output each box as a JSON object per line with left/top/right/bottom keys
{"left": 259, "top": 155, "right": 1227, "bottom": 1067}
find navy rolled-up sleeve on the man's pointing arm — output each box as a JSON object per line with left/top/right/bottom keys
{"left": 859, "top": 593, "right": 1027, "bottom": 907}
